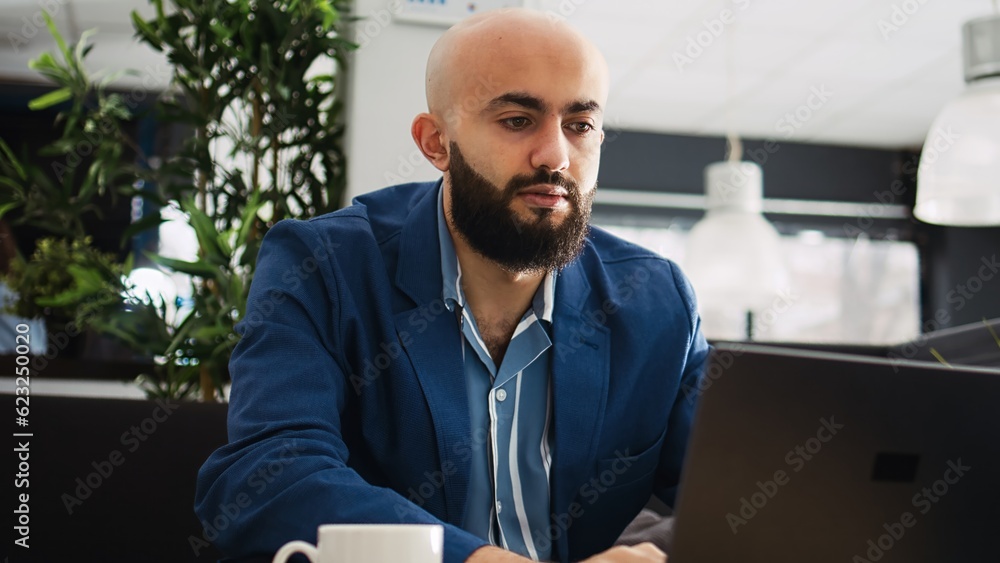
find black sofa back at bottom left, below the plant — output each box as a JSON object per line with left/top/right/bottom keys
{"left": 0, "top": 393, "right": 226, "bottom": 563}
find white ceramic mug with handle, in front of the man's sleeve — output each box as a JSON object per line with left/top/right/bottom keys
{"left": 272, "top": 524, "right": 444, "bottom": 563}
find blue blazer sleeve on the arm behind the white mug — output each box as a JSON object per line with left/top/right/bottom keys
{"left": 195, "top": 218, "right": 486, "bottom": 563}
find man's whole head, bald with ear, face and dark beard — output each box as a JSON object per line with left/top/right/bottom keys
{"left": 411, "top": 9, "right": 608, "bottom": 282}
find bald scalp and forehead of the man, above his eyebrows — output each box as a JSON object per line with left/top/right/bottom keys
{"left": 426, "top": 8, "right": 608, "bottom": 124}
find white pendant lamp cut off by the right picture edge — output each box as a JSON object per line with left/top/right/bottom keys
{"left": 913, "top": 14, "right": 1000, "bottom": 227}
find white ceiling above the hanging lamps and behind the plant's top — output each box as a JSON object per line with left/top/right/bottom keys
{"left": 0, "top": 0, "right": 996, "bottom": 147}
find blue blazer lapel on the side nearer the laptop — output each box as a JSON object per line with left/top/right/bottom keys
{"left": 550, "top": 251, "right": 611, "bottom": 560}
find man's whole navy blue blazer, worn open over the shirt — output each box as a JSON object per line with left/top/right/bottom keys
{"left": 195, "top": 181, "right": 708, "bottom": 563}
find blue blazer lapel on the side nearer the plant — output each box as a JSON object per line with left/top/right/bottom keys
{"left": 395, "top": 183, "right": 471, "bottom": 525}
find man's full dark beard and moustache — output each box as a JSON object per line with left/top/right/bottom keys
{"left": 449, "top": 142, "right": 597, "bottom": 274}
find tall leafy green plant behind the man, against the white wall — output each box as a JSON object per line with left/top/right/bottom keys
{"left": 0, "top": 0, "right": 354, "bottom": 400}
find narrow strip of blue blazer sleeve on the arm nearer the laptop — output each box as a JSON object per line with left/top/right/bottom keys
{"left": 654, "top": 263, "right": 710, "bottom": 507}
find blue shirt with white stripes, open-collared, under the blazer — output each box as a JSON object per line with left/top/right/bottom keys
{"left": 438, "top": 186, "right": 556, "bottom": 561}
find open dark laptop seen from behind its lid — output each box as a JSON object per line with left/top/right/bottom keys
{"left": 670, "top": 344, "right": 1000, "bottom": 563}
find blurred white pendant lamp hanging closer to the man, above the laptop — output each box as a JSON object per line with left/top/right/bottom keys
{"left": 684, "top": 161, "right": 787, "bottom": 339}
